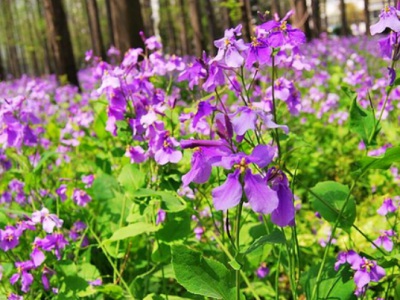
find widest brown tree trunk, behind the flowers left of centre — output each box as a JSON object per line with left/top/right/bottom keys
{"left": 110, "top": 0, "right": 144, "bottom": 53}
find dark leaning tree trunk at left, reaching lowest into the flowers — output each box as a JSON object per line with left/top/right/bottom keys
{"left": 44, "top": 0, "right": 79, "bottom": 87}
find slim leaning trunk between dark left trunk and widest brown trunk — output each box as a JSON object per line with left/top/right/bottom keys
{"left": 86, "top": 0, "right": 106, "bottom": 60}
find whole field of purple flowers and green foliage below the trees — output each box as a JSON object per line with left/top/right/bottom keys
{"left": 0, "top": 7, "right": 400, "bottom": 300}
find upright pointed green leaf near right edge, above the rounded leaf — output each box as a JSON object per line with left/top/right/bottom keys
{"left": 342, "top": 87, "right": 380, "bottom": 145}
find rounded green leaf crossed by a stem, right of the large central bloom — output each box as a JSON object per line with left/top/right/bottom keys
{"left": 310, "top": 181, "right": 356, "bottom": 229}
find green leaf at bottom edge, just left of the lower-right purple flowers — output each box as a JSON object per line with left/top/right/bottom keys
{"left": 301, "top": 259, "right": 357, "bottom": 300}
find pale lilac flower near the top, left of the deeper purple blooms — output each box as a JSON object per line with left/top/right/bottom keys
{"left": 210, "top": 24, "right": 248, "bottom": 68}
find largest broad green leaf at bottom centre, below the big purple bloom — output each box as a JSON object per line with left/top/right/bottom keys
{"left": 172, "top": 245, "right": 235, "bottom": 300}
